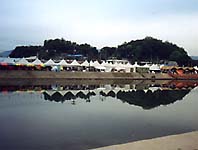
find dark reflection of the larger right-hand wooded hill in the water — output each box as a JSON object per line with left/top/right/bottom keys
{"left": 117, "top": 90, "right": 190, "bottom": 109}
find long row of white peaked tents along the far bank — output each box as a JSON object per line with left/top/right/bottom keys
{"left": 0, "top": 58, "right": 167, "bottom": 72}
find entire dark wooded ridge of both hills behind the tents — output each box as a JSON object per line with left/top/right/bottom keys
{"left": 10, "top": 37, "right": 191, "bottom": 65}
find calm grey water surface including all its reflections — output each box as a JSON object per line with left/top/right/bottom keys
{"left": 0, "top": 83, "right": 198, "bottom": 150}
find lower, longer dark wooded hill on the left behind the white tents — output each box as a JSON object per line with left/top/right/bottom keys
{"left": 10, "top": 39, "right": 98, "bottom": 59}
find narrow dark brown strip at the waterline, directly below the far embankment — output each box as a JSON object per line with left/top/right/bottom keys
{"left": 0, "top": 79, "right": 170, "bottom": 86}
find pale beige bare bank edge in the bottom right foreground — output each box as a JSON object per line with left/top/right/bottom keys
{"left": 95, "top": 131, "right": 198, "bottom": 150}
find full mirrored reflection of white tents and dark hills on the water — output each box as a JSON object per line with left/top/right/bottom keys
{"left": 0, "top": 81, "right": 198, "bottom": 109}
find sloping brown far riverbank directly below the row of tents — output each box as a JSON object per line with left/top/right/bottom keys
{"left": 0, "top": 70, "right": 173, "bottom": 80}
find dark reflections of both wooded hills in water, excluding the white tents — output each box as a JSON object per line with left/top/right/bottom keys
{"left": 43, "top": 89, "right": 191, "bottom": 109}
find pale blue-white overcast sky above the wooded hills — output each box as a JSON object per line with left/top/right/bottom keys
{"left": 0, "top": 0, "right": 198, "bottom": 55}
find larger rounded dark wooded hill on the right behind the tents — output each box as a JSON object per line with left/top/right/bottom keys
{"left": 101, "top": 37, "right": 191, "bottom": 65}
